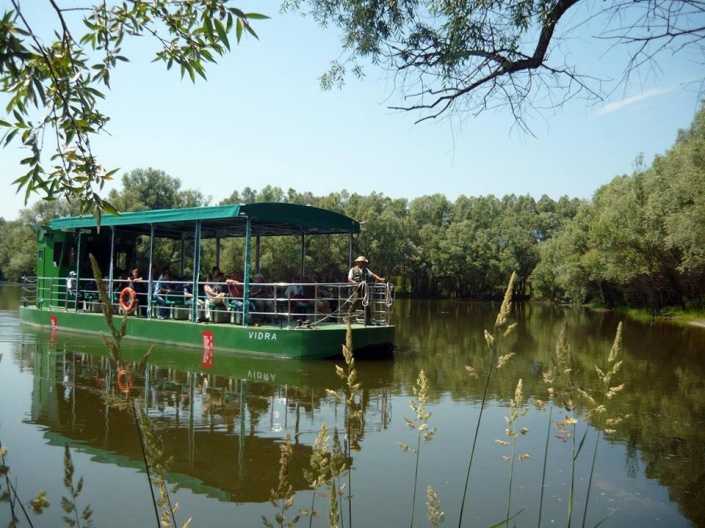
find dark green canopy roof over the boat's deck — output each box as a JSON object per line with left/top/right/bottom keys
{"left": 50, "top": 202, "right": 360, "bottom": 239}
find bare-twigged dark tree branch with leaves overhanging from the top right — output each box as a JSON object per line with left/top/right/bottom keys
{"left": 284, "top": 0, "right": 705, "bottom": 123}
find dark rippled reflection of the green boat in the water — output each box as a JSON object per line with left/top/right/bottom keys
{"left": 32, "top": 334, "right": 393, "bottom": 503}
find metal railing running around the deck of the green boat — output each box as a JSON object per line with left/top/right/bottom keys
{"left": 22, "top": 277, "right": 394, "bottom": 327}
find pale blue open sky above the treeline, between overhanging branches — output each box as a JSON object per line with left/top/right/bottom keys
{"left": 0, "top": 1, "right": 704, "bottom": 220}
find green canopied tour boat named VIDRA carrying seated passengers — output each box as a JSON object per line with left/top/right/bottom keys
{"left": 20, "top": 203, "right": 395, "bottom": 359}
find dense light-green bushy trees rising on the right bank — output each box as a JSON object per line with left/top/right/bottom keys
{"left": 532, "top": 104, "right": 705, "bottom": 314}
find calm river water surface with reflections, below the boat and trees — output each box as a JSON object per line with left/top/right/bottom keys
{"left": 0, "top": 285, "right": 705, "bottom": 528}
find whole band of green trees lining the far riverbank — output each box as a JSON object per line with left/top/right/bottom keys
{"left": 0, "top": 104, "right": 705, "bottom": 316}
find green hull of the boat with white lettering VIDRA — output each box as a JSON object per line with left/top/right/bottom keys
{"left": 20, "top": 306, "right": 395, "bottom": 359}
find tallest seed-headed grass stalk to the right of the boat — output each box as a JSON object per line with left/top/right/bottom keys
{"left": 458, "top": 273, "right": 516, "bottom": 528}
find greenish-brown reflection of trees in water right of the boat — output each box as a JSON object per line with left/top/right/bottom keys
{"left": 395, "top": 301, "right": 705, "bottom": 527}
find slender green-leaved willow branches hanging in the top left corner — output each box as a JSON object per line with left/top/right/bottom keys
{"left": 0, "top": 0, "right": 266, "bottom": 217}
